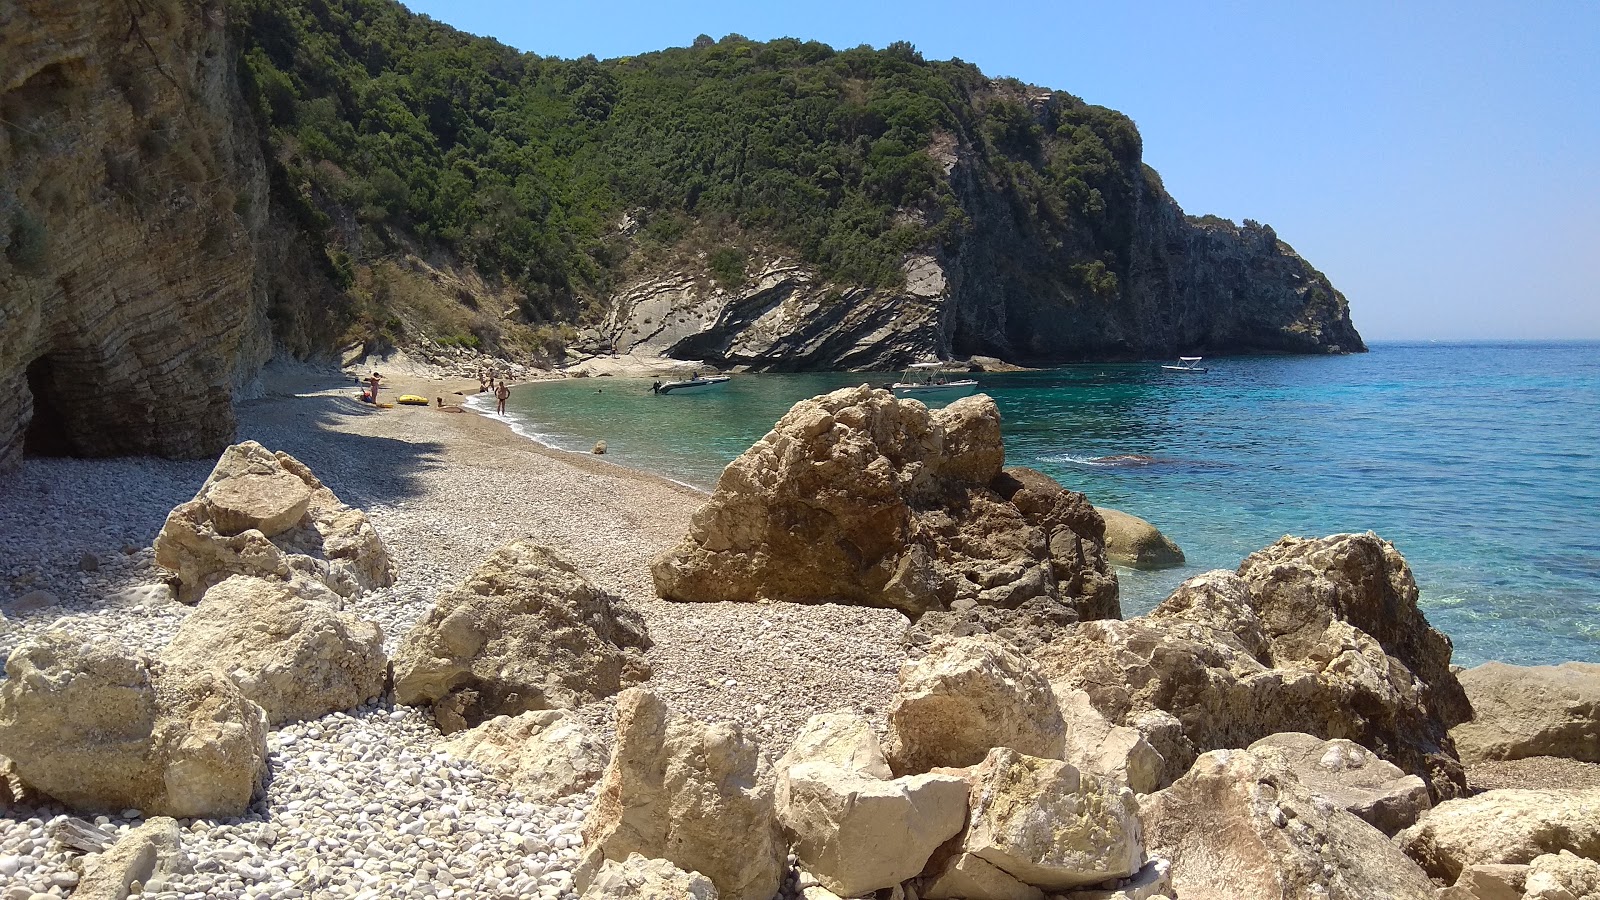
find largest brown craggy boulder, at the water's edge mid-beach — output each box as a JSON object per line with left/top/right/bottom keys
{"left": 651, "top": 386, "right": 1118, "bottom": 621}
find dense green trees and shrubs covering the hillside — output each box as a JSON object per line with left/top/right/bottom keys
{"left": 232, "top": 0, "right": 1144, "bottom": 328}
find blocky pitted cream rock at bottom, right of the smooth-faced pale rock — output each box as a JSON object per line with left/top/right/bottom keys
{"left": 960, "top": 748, "right": 1144, "bottom": 890}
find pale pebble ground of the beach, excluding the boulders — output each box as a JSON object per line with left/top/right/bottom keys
{"left": 0, "top": 365, "right": 906, "bottom": 900}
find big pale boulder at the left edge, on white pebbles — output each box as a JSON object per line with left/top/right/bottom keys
{"left": 0, "top": 631, "right": 267, "bottom": 817}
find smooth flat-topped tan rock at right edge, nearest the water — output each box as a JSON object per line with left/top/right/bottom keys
{"left": 1450, "top": 663, "right": 1600, "bottom": 765}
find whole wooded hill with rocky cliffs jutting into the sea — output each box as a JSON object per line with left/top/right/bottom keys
{"left": 230, "top": 0, "right": 1363, "bottom": 368}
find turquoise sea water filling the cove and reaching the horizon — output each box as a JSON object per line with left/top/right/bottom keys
{"left": 480, "top": 343, "right": 1600, "bottom": 665}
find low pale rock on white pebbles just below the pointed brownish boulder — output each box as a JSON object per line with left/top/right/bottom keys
{"left": 438, "top": 709, "right": 606, "bottom": 802}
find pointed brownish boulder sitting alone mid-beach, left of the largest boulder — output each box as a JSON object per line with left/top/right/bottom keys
{"left": 394, "top": 538, "right": 650, "bottom": 733}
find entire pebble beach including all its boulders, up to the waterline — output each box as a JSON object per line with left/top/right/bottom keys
{"left": 0, "top": 376, "right": 1600, "bottom": 900}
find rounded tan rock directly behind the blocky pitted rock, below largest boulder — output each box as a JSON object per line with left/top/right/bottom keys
{"left": 886, "top": 636, "right": 1066, "bottom": 775}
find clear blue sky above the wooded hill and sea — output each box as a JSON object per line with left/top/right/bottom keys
{"left": 406, "top": 0, "right": 1600, "bottom": 340}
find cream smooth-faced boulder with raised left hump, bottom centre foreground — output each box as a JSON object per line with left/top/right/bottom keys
{"left": 774, "top": 713, "right": 966, "bottom": 897}
